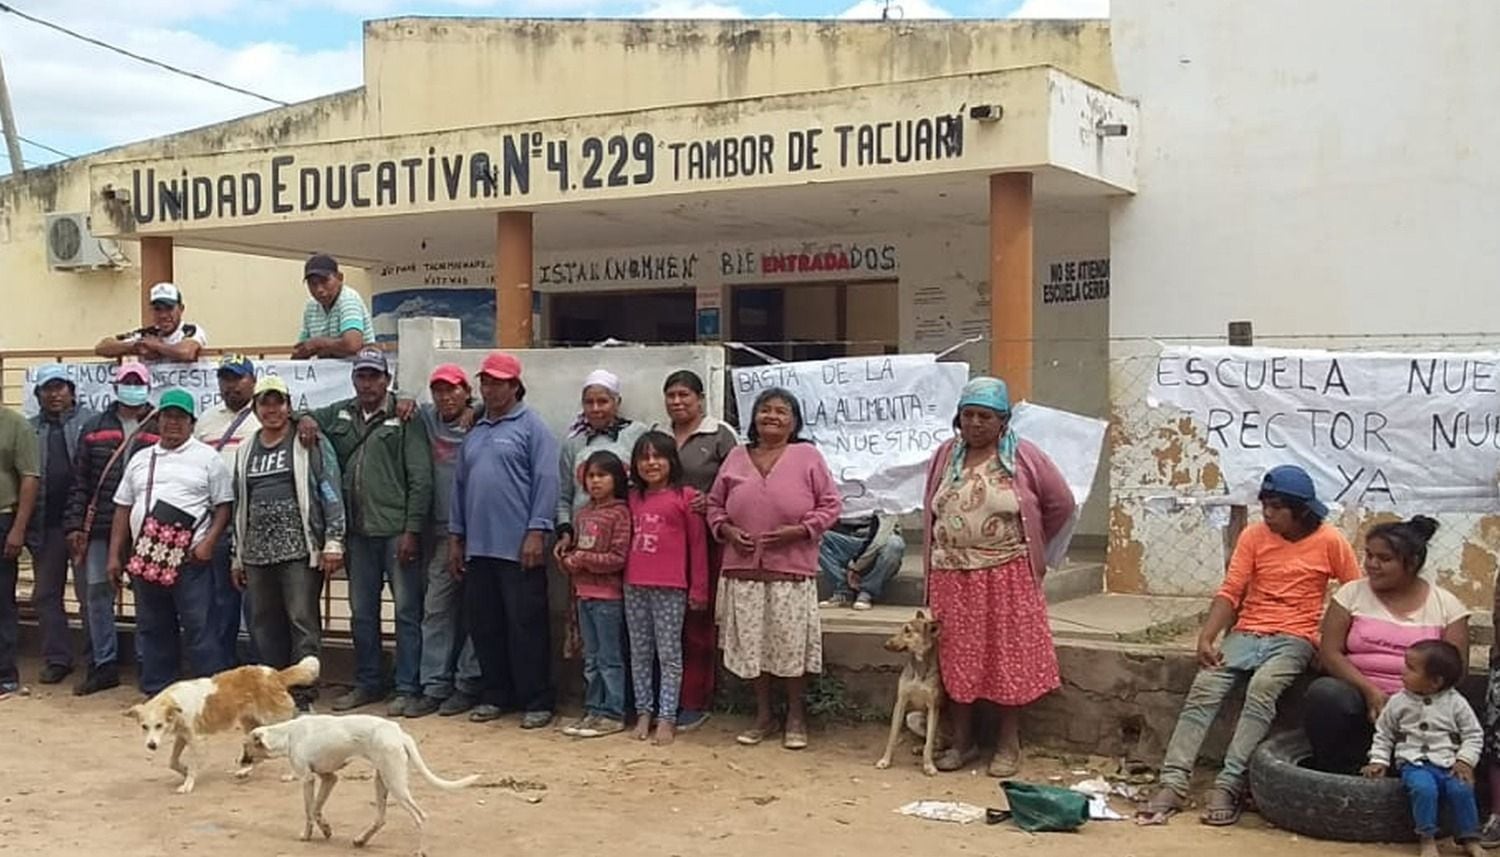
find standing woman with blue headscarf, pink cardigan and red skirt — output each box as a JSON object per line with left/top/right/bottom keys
{"left": 926, "top": 378, "right": 1074, "bottom": 777}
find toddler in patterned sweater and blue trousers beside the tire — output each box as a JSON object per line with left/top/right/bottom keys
{"left": 1362, "top": 639, "right": 1485, "bottom": 857}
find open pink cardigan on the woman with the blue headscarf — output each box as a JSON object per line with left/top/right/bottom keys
{"left": 923, "top": 440, "right": 1076, "bottom": 585}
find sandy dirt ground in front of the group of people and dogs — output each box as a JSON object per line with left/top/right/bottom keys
{"left": 0, "top": 663, "right": 1415, "bottom": 857}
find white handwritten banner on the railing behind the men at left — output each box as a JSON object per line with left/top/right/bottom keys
{"left": 23, "top": 360, "right": 361, "bottom": 416}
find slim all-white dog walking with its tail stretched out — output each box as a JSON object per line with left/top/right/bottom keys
{"left": 240, "top": 714, "right": 479, "bottom": 857}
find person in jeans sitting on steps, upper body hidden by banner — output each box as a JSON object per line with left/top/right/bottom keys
{"left": 818, "top": 512, "right": 906, "bottom": 609}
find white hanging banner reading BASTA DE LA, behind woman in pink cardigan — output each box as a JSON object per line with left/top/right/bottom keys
{"left": 731, "top": 354, "right": 969, "bottom": 515}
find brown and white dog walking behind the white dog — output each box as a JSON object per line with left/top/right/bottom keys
{"left": 125, "top": 656, "right": 318, "bottom": 794}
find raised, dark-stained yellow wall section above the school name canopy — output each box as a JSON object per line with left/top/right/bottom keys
{"left": 365, "top": 18, "right": 1116, "bottom": 134}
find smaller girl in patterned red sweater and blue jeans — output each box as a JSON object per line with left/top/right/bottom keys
{"left": 558, "top": 452, "right": 630, "bottom": 738}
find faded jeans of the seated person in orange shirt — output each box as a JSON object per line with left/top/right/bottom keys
{"left": 1161, "top": 630, "right": 1314, "bottom": 797}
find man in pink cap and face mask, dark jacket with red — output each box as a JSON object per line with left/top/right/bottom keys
{"left": 63, "top": 363, "right": 158, "bottom": 696}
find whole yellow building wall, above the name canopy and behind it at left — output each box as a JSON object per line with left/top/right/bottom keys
{"left": 0, "top": 18, "right": 1115, "bottom": 348}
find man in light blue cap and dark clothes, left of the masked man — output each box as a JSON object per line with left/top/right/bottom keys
{"left": 26, "top": 363, "right": 96, "bottom": 684}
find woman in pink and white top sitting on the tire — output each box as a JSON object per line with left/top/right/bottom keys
{"left": 1302, "top": 515, "right": 1469, "bottom": 774}
